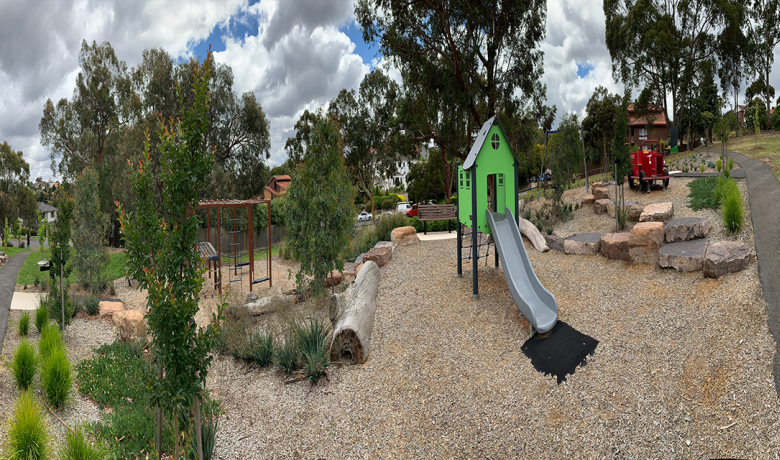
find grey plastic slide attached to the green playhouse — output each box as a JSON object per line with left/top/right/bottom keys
{"left": 487, "top": 208, "right": 558, "bottom": 334}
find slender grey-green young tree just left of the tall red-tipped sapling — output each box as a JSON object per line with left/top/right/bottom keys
{"left": 72, "top": 169, "right": 109, "bottom": 292}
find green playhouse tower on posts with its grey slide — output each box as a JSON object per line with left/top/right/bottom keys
{"left": 457, "top": 117, "right": 558, "bottom": 334}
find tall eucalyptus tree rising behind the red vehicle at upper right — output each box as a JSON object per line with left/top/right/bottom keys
{"left": 603, "top": 0, "right": 740, "bottom": 133}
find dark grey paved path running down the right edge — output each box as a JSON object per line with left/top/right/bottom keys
{"left": 728, "top": 152, "right": 780, "bottom": 395}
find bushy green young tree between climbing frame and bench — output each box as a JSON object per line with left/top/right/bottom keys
{"left": 286, "top": 114, "right": 355, "bottom": 293}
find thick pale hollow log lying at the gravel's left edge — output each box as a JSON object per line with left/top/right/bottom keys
{"left": 328, "top": 261, "right": 382, "bottom": 364}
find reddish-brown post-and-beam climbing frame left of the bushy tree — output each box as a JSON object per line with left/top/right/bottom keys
{"left": 197, "top": 198, "right": 273, "bottom": 294}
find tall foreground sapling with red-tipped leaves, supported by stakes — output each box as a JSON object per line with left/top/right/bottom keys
{"left": 116, "top": 52, "right": 224, "bottom": 458}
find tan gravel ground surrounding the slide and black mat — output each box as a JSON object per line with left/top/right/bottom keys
{"left": 208, "top": 232, "right": 780, "bottom": 459}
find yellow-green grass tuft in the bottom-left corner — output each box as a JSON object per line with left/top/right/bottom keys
{"left": 3, "top": 391, "right": 51, "bottom": 460}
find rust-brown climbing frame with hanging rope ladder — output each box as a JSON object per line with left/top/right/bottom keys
{"left": 197, "top": 199, "right": 273, "bottom": 294}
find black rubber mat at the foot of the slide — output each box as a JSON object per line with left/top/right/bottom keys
{"left": 522, "top": 321, "right": 599, "bottom": 385}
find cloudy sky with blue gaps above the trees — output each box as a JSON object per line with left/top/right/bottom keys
{"left": 0, "top": 0, "right": 768, "bottom": 179}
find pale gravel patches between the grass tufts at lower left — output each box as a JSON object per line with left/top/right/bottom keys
{"left": 0, "top": 311, "right": 115, "bottom": 445}
